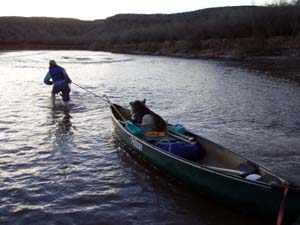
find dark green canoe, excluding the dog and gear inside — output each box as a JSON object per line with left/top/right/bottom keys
{"left": 110, "top": 103, "right": 300, "bottom": 224}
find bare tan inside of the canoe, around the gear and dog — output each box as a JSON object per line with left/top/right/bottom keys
{"left": 111, "top": 105, "right": 287, "bottom": 185}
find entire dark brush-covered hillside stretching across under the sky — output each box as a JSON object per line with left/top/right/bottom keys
{"left": 0, "top": 6, "right": 300, "bottom": 56}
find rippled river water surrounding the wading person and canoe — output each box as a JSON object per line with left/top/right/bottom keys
{"left": 0, "top": 51, "right": 300, "bottom": 225}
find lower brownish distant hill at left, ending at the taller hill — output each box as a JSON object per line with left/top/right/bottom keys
{"left": 0, "top": 17, "right": 102, "bottom": 49}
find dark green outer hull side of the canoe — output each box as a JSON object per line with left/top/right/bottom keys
{"left": 112, "top": 105, "right": 300, "bottom": 224}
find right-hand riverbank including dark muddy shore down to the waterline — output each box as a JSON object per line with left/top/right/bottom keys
{"left": 103, "top": 35, "right": 300, "bottom": 84}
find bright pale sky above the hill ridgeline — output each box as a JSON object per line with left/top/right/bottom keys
{"left": 0, "top": 0, "right": 266, "bottom": 20}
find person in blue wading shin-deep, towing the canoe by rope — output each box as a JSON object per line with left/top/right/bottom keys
{"left": 44, "top": 60, "right": 72, "bottom": 107}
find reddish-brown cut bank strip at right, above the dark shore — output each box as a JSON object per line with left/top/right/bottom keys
{"left": 102, "top": 35, "right": 300, "bottom": 60}
